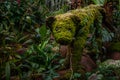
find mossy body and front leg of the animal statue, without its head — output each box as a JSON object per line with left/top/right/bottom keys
{"left": 72, "top": 6, "right": 101, "bottom": 72}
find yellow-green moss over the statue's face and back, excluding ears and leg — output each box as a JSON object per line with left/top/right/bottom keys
{"left": 52, "top": 5, "right": 100, "bottom": 44}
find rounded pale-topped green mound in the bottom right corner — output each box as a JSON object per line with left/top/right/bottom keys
{"left": 98, "top": 60, "right": 120, "bottom": 80}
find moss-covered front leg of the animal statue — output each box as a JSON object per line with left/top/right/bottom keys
{"left": 72, "top": 33, "right": 88, "bottom": 72}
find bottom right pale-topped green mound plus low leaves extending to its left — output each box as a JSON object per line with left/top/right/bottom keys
{"left": 85, "top": 60, "right": 120, "bottom": 80}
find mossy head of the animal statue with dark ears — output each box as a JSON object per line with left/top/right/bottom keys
{"left": 46, "top": 13, "right": 80, "bottom": 45}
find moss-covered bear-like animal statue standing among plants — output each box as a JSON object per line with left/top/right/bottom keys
{"left": 46, "top": 5, "right": 102, "bottom": 79}
